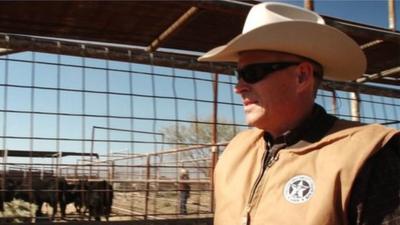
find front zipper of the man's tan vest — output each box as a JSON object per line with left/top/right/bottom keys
{"left": 242, "top": 145, "right": 278, "bottom": 225}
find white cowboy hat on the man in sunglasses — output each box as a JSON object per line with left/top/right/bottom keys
{"left": 198, "top": 2, "right": 367, "bottom": 81}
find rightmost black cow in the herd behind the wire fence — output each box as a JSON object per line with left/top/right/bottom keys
{"left": 69, "top": 180, "right": 114, "bottom": 221}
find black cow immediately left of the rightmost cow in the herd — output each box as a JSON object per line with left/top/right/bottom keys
{"left": 15, "top": 177, "right": 69, "bottom": 220}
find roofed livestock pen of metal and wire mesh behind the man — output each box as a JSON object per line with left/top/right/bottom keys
{"left": 0, "top": 1, "right": 400, "bottom": 225}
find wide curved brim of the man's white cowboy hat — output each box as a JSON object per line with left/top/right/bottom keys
{"left": 198, "top": 21, "right": 367, "bottom": 81}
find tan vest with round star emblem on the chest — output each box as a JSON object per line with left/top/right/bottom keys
{"left": 214, "top": 125, "right": 397, "bottom": 225}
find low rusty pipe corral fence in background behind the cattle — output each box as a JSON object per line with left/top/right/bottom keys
{"left": 1, "top": 144, "right": 226, "bottom": 222}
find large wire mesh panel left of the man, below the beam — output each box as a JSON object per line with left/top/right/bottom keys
{"left": 0, "top": 46, "right": 238, "bottom": 220}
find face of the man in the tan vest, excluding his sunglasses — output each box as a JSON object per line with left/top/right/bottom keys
{"left": 235, "top": 50, "right": 301, "bottom": 133}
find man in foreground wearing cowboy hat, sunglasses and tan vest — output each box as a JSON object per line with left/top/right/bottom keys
{"left": 199, "top": 2, "right": 400, "bottom": 225}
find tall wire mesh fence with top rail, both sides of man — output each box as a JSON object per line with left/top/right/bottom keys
{"left": 0, "top": 35, "right": 400, "bottom": 221}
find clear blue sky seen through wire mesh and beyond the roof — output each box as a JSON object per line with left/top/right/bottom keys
{"left": 0, "top": 0, "right": 400, "bottom": 172}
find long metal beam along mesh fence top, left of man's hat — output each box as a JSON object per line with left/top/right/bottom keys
{"left": 0, "top": 33, "right": 233, "bottom": 74}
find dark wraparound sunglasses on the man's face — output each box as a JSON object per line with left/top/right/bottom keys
{"left": 235, "top": 62, "right": 300, "bottom": 84}
